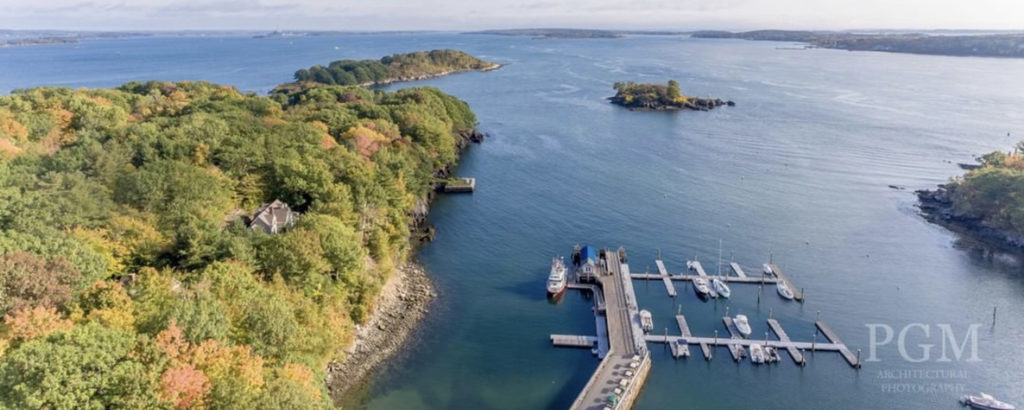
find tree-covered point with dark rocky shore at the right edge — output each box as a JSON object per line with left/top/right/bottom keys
{"left": 916, "top": 148, "right": 1024, "bottom": 249}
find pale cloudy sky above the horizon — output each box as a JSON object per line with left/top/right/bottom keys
{"left": 0, "top": 0, "right": 1024, "bottom": 31}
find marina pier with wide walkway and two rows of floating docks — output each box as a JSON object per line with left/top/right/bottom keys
{"left": 550, "top": 247, "right": 860, "bottom": 410}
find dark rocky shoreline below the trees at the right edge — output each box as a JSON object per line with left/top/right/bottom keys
{"left": 914, "top": 185, "right": 1024, "bottom": 250}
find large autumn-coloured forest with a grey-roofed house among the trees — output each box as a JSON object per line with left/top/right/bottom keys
{"left": 0, "top": 82, "right": 476, "bottom": 409}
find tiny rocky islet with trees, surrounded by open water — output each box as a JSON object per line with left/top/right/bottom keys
{"left": 608, "top": 80, "right": 736, "bottom": 111}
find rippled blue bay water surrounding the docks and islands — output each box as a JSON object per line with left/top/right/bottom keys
{"left": 0, "top": 34, "right": 1024, "bottom": 409}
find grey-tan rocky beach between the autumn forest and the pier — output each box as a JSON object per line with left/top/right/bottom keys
{"left": 327, "top": 263, "right": 437, "bottom": 404}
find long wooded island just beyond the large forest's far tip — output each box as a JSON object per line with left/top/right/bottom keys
{"left": 286, "top": 50, "right": 501, "bottom": 86}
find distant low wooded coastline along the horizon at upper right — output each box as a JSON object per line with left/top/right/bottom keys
{"left": 691, "top": 30, "right": 1024, "bottom": 58}
